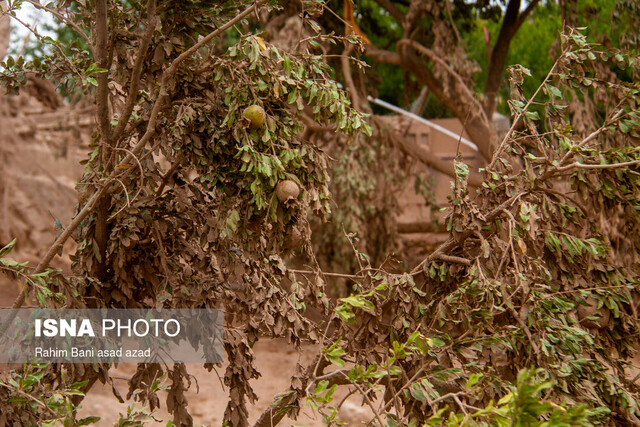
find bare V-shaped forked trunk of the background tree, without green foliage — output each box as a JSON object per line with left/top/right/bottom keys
{"left": 336, "top": 0, "right": 539, "bottom": 164}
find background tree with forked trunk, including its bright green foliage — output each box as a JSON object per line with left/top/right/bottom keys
{"left": 336, "top": 0, "right": 634, "bottom": 175}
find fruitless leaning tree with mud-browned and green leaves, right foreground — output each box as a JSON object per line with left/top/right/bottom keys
{"left": 262, "top": 30, "right": 640, "bottom": 425}
